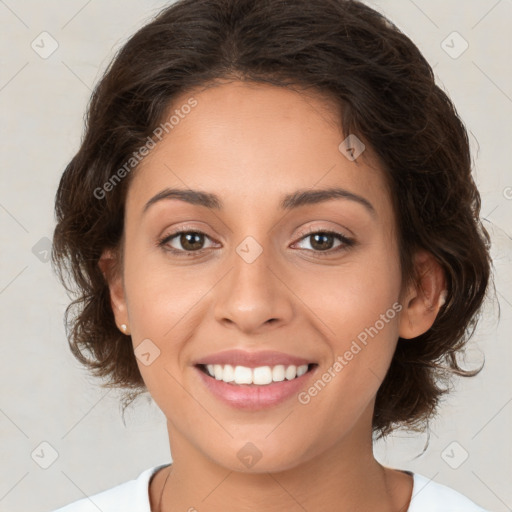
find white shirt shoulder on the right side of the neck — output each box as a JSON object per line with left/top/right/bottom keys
{"left": 407, "top": 473, "right": 487, "bottom": 512}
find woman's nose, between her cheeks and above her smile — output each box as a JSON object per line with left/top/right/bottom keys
{"left": 214, "top": 242, "right": 294, "bottom": 334}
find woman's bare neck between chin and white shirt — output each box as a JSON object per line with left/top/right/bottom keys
{"left": 155, "top": 418, "right": 412, "bottom": 512}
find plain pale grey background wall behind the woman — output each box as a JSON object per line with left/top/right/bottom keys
{"left": 0, "top": 0, "right": 512, "bottom": 512}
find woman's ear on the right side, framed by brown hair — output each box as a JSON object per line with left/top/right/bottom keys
{"left": 399, "top": 250, "right": 447, "bottom": 339}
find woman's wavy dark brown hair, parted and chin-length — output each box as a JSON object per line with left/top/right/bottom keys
{"left": 52, "top": 0, "right": 491, "bottom": 437}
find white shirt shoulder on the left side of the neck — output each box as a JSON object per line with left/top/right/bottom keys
{"left": 49, "top": 464, "right": 167, "bottom": 512}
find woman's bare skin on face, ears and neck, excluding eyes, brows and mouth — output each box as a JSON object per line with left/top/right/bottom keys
{"left": 100, "top": 81, "right": 445, "bottom": 512}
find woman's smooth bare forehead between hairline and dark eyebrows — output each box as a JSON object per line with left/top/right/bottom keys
{"left": 127, "top": 82, "right": 390, "bottom": 220}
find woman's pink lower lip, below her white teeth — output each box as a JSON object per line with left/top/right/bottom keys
{"left": 194, "top": 366, "right": 318, "bottom": 411}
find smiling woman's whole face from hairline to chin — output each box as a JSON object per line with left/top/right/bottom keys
{"left": 108, "top": 82, "right": 412, "bottom": 472}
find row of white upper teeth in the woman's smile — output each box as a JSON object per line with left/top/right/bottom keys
{"left": 206, "top": 364, "right": 308, "bottom": 386}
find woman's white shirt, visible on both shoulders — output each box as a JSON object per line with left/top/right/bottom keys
{"left": 53, "top": 464, "right": 487, "bottom": 512}
